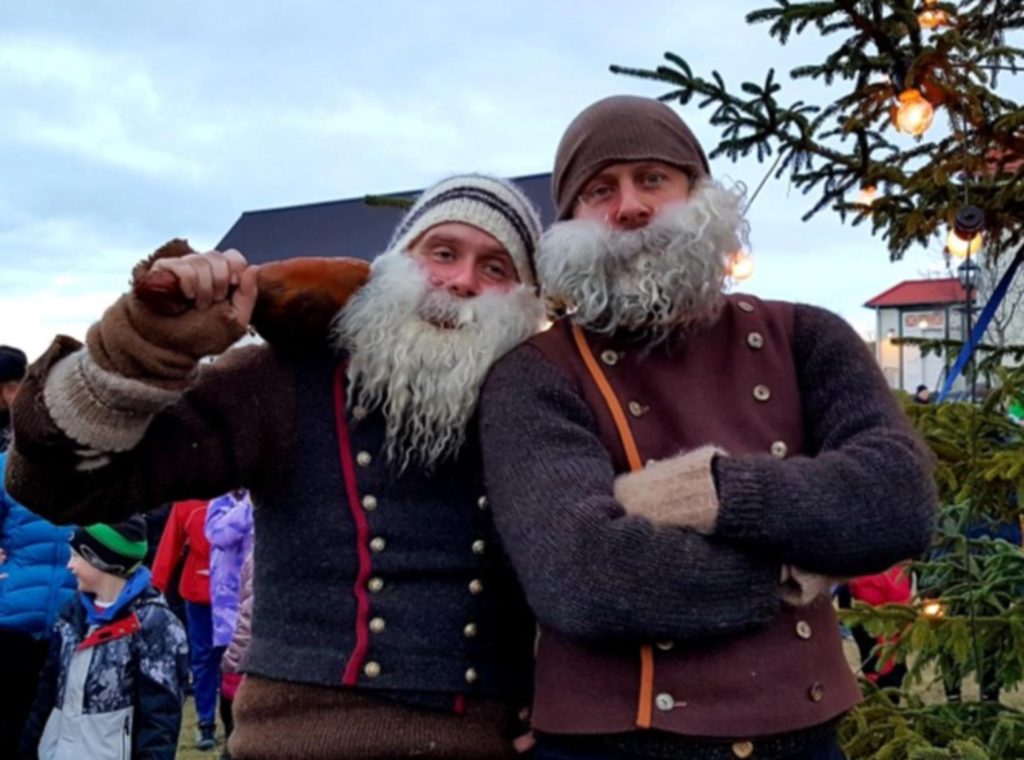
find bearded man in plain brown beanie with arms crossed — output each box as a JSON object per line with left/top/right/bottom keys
{"left": 480, "top": 96, "right": 936, "bottom": 760}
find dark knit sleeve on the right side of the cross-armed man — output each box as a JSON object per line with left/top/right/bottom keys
{"left": 715, "top": 305, "right": 937, "bottom": 576}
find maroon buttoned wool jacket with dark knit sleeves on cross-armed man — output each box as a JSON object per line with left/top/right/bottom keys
{"left": 481, "top": 296, "right": 935, "bottom": 740}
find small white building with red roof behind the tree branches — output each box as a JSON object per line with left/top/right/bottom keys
{"left": 864, "top": 278, "right": 967, "bottom": 393}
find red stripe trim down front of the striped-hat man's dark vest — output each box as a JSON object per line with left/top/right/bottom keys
{"left": 334, "top": 363, "right": 370, "bottom": 686}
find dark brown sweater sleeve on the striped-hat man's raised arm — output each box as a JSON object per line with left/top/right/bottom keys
{"left": 5, "top": 337, "right": 295, "bottom": 524}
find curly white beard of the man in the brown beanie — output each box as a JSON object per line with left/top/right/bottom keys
{"left": 537, "top": 179, "right": 748, "bottom": 339}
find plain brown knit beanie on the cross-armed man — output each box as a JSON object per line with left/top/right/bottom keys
{"left": 551, "top": 95, "right": 711, "bottom": 221}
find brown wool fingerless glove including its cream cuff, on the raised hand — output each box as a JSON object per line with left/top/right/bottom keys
{"left": 43, "top": 240, "right": 246, "bottom": 452}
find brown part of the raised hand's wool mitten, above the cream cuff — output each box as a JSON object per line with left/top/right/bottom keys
{"left": 86, "top": 240, "right": 246, "bottom": 390}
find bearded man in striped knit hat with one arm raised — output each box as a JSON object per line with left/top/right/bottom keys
{"left": 6, "top": 175, "right": 544, "bottom": 760}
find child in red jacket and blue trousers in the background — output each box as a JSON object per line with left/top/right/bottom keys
{"left": 153, "top": 501, "right": 220, "bottom": 751}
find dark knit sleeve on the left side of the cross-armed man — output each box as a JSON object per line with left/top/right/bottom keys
{"left": 480, "top": 346, "right": 779, "bottom": 640}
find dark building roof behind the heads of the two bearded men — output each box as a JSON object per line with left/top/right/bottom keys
{"left": 217, "top": 174, "right": 555, "bottom": 264}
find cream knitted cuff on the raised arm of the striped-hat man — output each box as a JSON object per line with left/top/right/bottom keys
{"left": 43, "top": 348, "right": 181, "bottom": 452}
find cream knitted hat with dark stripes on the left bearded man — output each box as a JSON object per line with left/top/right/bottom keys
{"left": 388, "top": 174, "right": 541, "bottom": 287}
